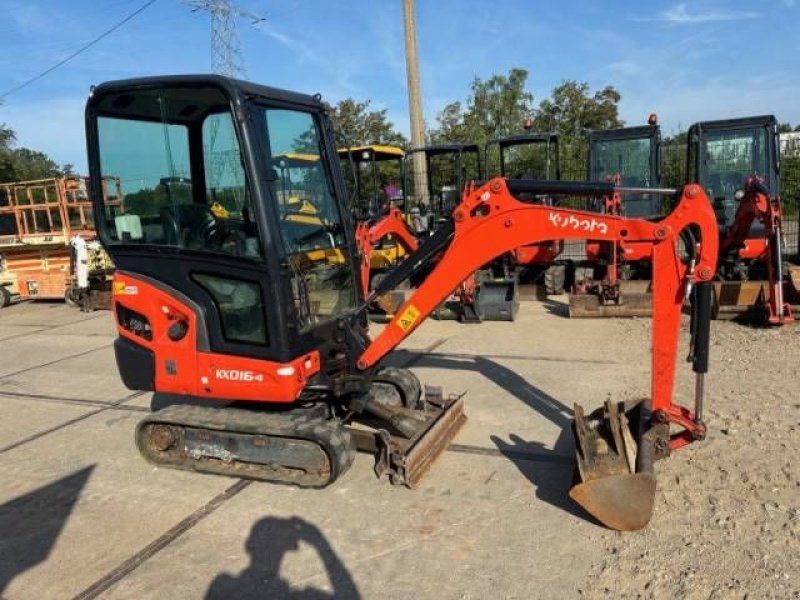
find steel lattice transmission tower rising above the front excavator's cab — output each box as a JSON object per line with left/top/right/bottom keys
{"left": 182, "top": 0, "right": 264, "bottom": 77}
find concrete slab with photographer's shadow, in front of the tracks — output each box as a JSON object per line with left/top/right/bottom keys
{"left": 98, "top": 454, "right": 592, "bottom": 599}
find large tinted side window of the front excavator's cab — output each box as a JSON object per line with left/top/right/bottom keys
{"left": 97, "top": 88, "right": 262, "bottom": 259}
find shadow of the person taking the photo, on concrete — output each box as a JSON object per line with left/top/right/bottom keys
{"left": 206, "top": 517, "right": 361, "bottom": 600}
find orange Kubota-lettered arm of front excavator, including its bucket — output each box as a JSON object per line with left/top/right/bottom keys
{"left": 357, "top": 178, "right": 719, "bottom": 530}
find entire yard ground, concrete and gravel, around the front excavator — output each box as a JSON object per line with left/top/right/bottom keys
{"left": 0, "top": 301, "right": 800, "bottom": 600}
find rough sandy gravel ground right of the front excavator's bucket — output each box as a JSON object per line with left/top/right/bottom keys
{"left": 583, "top": 322, "right": 800, "bottom": 599}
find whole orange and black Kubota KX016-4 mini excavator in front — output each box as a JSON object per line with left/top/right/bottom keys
{"left": 86, "top": 75, "right": 718, "bottom": 529}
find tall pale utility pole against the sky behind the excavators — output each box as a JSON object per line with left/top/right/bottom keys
{"left": 403, "top": 0, "right": 429, "bottom": 203}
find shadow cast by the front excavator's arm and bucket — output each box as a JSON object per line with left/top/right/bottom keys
{"left": 394, "top": 350, "right": 596, "bottom": 522}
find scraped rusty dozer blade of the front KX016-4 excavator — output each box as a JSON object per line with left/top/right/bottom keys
{"left": 351, "top": 387, "right": 467, "bottom": 488}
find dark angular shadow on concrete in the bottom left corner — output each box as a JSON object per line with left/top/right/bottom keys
{"left": 0, "top": 465, "right": 94, "bottom": 594}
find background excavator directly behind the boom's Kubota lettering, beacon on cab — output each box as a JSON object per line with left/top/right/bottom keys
{"left": 569, "top": 114, "right": 665, "bottom": 318}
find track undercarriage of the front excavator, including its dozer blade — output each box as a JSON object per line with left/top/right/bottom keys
{"left": 136, "top": 368, "right": 466, "bottom": 488}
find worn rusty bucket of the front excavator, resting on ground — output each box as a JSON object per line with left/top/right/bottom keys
{"left": 569, "top": 400, "right": 669, "bottom": 531}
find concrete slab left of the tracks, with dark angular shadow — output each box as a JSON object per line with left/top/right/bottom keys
{"left": 0, "top": 410, "right": 231, "bottom": 600}
